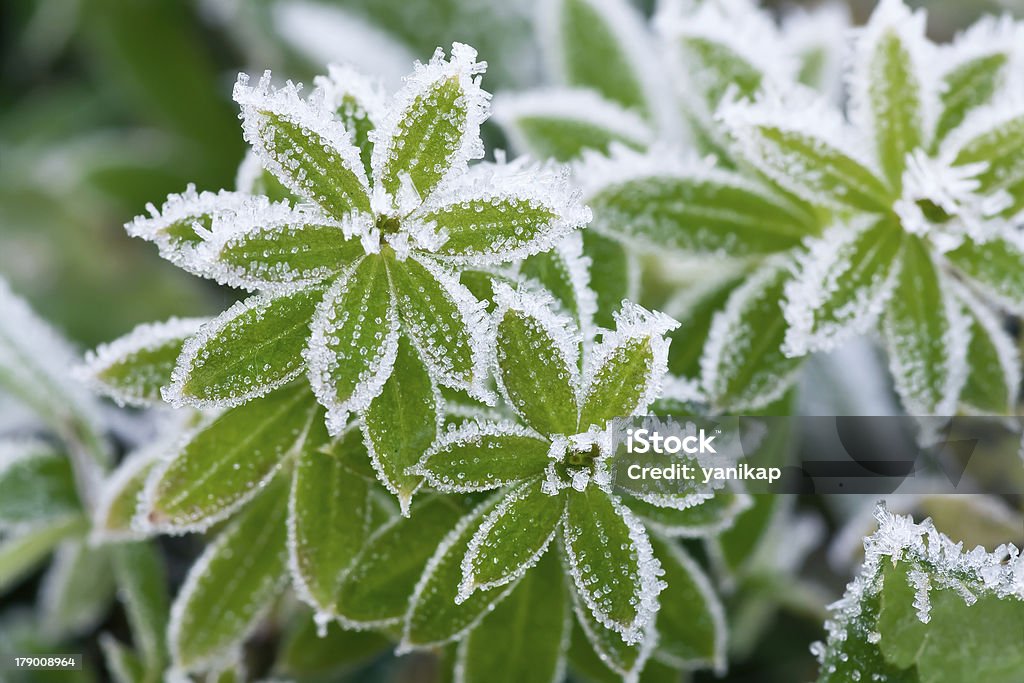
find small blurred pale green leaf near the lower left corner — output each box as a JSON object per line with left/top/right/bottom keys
{"left": 40, "top": 540, "right": 114, "bottom": 639}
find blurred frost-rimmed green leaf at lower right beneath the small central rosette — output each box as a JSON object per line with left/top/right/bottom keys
{"left": 651, "top": 538, "right": 726, "bottom": 671}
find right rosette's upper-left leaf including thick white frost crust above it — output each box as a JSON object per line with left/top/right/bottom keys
{"left": 721, "top": 97, "right": 895, "bottom": 213}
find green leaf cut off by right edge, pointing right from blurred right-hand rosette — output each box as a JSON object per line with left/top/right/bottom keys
{"left": 945, "top": 237, "right": 1024, "bottom": 314}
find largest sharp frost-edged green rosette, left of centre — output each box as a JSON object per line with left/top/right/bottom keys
{"left": 128, "top": 44, "right": 589, "bottom": 433}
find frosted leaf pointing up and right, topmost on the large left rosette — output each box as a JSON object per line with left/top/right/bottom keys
{"left": 373, "top": 43, "right": 490, "bottom": 198}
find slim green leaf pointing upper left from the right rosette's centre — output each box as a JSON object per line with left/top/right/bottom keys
{"left": 726, "top": 120, "right": 895, "bottom": 213}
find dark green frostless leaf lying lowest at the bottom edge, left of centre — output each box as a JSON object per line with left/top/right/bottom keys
{"left": 274, "top": 612, "right": 391, "bottom": 680}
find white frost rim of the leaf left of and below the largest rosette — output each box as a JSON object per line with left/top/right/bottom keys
{"left": 72, "top": 317, "right": 210, "bottom": 407}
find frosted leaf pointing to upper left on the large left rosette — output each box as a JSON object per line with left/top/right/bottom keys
{"left": 232, "top": 72, "right": 370, "bottom": 220}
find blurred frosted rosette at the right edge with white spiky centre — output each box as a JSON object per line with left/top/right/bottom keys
{"left": 721, "top": 0, "right": 1024, "bottom": 415}
